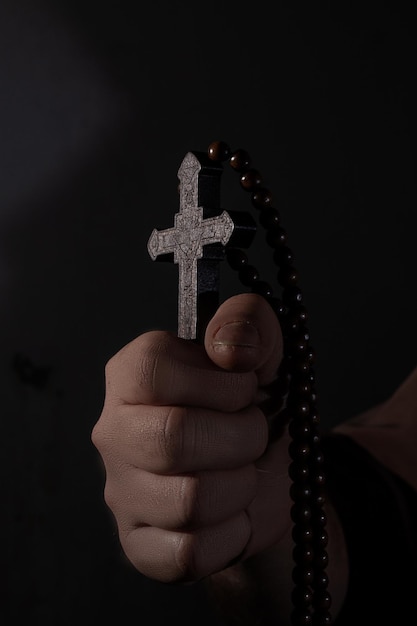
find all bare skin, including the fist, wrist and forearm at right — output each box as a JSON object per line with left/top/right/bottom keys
{"left": 92, "top": 294, "right": 417, "bottom": 626}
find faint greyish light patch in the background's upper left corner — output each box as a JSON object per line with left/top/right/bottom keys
{"left": 0, "top": 1, "right": 130, "bottom": 226}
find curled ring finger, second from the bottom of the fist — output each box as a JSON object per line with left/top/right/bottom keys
{"left": 105, "top": 464, "right": 258, "bottom": 531}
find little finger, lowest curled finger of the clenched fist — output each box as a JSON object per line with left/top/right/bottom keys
{"left": 120, "top": 513, "right": 251, "bottom": 582}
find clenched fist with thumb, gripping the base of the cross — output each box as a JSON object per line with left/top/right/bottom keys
{"left": 92, "top": 294, "right": 291, "bottom": 582}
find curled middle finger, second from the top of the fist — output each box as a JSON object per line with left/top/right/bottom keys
{"left": 93, "top": 405, "right": 268, "bottom": 474}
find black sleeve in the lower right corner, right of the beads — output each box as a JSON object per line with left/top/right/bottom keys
{"left": 323, "top": 434, "right": 417, "bottom": 626}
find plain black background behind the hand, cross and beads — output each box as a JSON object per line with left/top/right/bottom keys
{"left": 0, "top": 0, "right": 417, "bottom": 626}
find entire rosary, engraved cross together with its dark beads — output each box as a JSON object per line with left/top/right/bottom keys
{"left": 148, "top": 141, "right": 332, "bottom": 626}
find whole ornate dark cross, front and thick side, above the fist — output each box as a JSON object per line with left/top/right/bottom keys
{"left": 148, "top": 152, "right": 255, "bottom": 339}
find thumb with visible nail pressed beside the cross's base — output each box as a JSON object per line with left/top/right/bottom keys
{"left": 204, "top": 293, "right": 283, "bottom": 385}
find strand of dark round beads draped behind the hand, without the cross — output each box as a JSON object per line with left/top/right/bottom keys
{"left": 208, "top": 141, "right": 332, "bottom": 626}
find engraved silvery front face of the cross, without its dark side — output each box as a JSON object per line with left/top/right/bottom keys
{"left": 148, "top": 152, "right": 235, "bottom": 339}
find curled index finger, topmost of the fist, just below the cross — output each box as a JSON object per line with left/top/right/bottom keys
{"left": 106, "top": 331, "right": 258, "bottom": 411}
